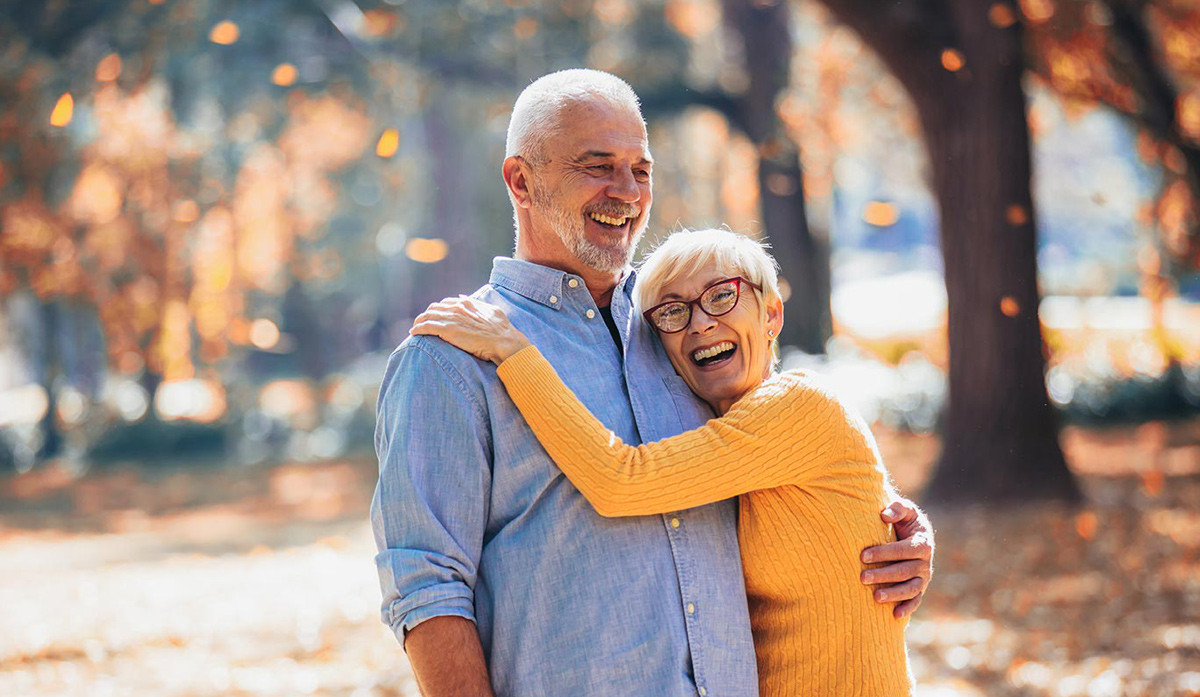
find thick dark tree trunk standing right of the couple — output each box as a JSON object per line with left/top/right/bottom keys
{"left": 826, "top": 0, "right": 1080, "bottom": 503}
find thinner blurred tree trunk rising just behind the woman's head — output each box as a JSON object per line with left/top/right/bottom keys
{"left": 724, "top": 0, "right": 833, "bottom": 354}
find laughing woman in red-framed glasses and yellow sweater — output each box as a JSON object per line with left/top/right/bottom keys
{"left": 413, "top": 230, "right": 911, "bottom": 697}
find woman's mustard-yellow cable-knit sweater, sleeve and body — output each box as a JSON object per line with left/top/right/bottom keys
{"left": 498, "top": 347, "right": 910, "bottom": 697}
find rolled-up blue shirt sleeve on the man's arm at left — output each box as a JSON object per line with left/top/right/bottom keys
{"left": 371, "top": 337, "right": 491, "bottom": 644}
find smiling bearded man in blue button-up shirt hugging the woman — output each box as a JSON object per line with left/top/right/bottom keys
{"left": 372, "top": 70, "right": 932, "bottom": 697}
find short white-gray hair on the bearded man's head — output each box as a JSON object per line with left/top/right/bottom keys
{"left": 504, "top": 68, "right": 642, "bottom": 164}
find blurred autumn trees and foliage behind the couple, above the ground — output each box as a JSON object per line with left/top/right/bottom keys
{"left": 0, "top": 0, "right": 1200, "bottom": 500}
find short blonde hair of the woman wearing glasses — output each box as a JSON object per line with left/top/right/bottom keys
{"left": 634, "top": 228, "right": 782, "bottom": 356}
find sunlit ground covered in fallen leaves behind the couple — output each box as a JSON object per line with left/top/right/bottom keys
{"left": 0, "top": 417, "right": 1200, "bottom": 697}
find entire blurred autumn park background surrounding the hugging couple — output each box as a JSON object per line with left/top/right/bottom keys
{"left": 0, "top": 0, "right": 1200, "bottom": 697}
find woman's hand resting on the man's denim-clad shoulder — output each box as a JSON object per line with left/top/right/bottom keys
{"left": 408, "top": 295, "right": 529, "bottom": 365}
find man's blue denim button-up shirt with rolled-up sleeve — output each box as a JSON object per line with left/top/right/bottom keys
{"left": 371, "top": 258, "right": 758, "bottom": 697}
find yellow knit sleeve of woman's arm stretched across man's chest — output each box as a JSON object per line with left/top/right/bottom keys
{"left": 498, "top": 346, "right": 877, "bottom": 516}
